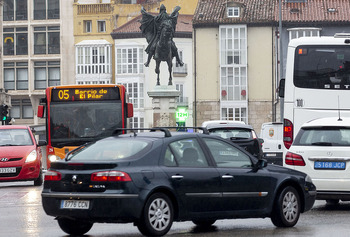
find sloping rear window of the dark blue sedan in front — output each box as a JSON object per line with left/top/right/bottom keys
{"left": 69, "top": 139, "right": 150, "bottom": 161}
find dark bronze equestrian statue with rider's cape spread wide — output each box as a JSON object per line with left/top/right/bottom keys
{"left": 140, "top": 4, "right": 183, "bottom": 85}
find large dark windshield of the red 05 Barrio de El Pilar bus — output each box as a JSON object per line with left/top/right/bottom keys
{"left": 50, "top": 100, "right": 122, "bottom": 147}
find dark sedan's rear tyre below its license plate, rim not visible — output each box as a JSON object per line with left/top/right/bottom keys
{"left": 57, "top": 218, "right": 93, "bottom": 235}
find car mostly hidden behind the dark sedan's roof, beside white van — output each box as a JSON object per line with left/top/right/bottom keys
{"left": 202, "top": 120, "right": 264, "bottom": 159}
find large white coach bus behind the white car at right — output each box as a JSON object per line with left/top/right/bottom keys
{"left": 279, "top": 33, "right": 350, "bottom": 149}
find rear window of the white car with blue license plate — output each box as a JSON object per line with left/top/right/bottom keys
{"left": 294, "top": 127, "right": 350, "bottom": 146}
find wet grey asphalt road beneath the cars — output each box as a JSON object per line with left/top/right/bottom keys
{"left": 0, "top": 182, "right": 350, "bottom": 237}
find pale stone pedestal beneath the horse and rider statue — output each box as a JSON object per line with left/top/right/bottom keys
{"left": 147, "top": 86, "right": 180, "bottom": 127}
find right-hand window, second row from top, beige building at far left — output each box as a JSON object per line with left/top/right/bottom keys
{"left": 34, "top": 26, "right": 60, "bottom": 54}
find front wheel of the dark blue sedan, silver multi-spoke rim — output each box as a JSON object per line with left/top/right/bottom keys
{"left": 271, "top": 186, "right": 300, "bottom": 227}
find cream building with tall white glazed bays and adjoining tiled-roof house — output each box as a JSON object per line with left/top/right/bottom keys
{"left": 193, "top": 0, "right": 350, "bottom": 131}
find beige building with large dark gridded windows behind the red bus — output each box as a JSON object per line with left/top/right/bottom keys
{"left": 0, "top": 0, "right": 74, "bottom": 124}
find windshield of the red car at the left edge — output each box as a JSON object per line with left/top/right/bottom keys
{"left": 0, "top": 129, "right": 33, "bottom": 146}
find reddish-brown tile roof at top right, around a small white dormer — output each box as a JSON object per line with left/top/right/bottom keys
{"left": 193, "top": 0, "right": 350, "bottom": 27}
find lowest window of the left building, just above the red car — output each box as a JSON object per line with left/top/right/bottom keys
{"left": 10, "top": 99, "right": 34, "bottom": 119}
